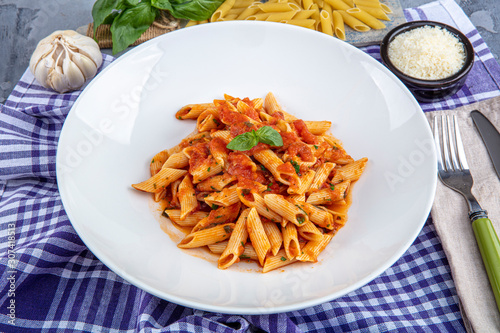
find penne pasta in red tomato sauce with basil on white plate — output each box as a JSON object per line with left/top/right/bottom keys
{"left": 132, "top": 92, "right": 368, "bottom": 273}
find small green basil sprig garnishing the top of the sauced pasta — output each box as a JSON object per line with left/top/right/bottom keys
{"left": 226, "top": 126, "right": 283, "bottom": 151}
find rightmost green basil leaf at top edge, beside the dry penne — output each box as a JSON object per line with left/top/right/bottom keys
{"left": 156, "top": 0, "right": 224, "bottom": 21}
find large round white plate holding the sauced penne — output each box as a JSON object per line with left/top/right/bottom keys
{"left": 57, "top": 22, "right": 436, "bottom": 314}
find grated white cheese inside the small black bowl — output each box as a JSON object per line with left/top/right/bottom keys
{"left": 388, "top": 26, "right": 465, "bottom": 80}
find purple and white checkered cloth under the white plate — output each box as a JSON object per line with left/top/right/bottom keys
{"left": 0, "top": 0, "right": 500, "bottom": 332}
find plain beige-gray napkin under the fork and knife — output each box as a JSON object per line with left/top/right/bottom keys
{"left": 426, "top": 97, "right": 500, "bottom": 332}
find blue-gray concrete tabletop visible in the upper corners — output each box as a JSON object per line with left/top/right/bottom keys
{"left": 0, "top": 0, "right": 500, "bottom": 103}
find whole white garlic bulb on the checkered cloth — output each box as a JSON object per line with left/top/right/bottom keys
{"left": 29, "top": 30, "right": 102, "bottom": 93}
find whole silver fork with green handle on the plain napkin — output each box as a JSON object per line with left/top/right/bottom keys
{"left": 433, "top": 115, "right": 500, "bottom": 310}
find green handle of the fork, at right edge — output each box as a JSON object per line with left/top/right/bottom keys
{"left": 472, "top": 218, "right": 500, "bottom": 311}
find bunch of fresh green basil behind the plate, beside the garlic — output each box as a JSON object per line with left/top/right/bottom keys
{"left": 92, "top": 0, "right": 224, "bottom": 54}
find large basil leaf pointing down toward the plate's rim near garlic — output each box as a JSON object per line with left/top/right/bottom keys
{"left": 110, "top": 1, "right": 158, "bottom": 54}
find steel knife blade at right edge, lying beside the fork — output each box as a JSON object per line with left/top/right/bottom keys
{"left": 470, "top": 110, "right": 500, "bottom": 178}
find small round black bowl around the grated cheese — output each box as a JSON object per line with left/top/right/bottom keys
{"left": 380, "top": 21, "right": 474, "bottom": 103}
